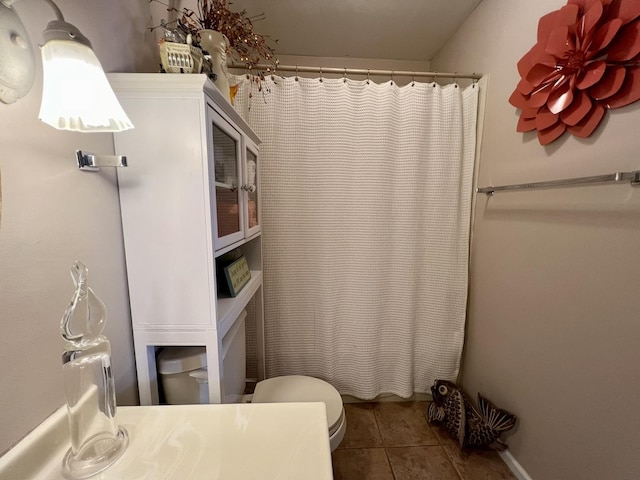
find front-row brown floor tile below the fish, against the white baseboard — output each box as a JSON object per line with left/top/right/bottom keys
{"left": 443, "top": 445, "right": 516, "bottom": 480}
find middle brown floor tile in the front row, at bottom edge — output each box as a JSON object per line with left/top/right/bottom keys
{"left": 386, "top": 446, "right": 460, "bottom": 480}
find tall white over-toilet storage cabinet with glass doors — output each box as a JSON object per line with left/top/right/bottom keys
{"left": 109, "top": 74, "right": 264, "bottom": 405}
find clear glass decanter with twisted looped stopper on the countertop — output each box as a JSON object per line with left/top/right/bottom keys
{"left": 60, "top": 262, "right": 129, "bottom": 480}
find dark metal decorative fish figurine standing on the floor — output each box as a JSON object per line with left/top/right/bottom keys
{"left": 427, "top": 380, "right": 517, "bottom": 450}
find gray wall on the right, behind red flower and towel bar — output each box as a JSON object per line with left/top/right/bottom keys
{"left": 432, "top": 0, "right": 640, "bottom": 480}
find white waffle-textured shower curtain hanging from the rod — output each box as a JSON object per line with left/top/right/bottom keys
{"left": 232, "top": 76, "right": 478, "bottom": 399}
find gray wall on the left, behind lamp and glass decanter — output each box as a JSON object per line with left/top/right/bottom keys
{"left": 0, "top": 0, "right": 158, "bottom": 454}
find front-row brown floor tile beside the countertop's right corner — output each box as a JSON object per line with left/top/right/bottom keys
{"left": 331, "top": 448, "right": 394, "bottom": 480}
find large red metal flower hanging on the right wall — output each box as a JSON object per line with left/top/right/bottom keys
{"left": 509, "top": 0, "right": 640, "bottom": 145}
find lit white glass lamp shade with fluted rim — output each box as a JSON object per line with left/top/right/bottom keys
{"left": 38, "top": 39, "right": 133, "bottom": 132}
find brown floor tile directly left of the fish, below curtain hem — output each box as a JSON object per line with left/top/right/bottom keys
{"left": 376, "top": 402, "right": 440, "bottom": 447}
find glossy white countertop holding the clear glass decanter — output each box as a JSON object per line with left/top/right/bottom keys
{"left": 0, "top": 403, "right": 333, "bottom": 480}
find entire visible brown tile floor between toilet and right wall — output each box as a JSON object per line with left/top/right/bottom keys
{"left": 332, "top": 402, "right": 516, "bottom": 480}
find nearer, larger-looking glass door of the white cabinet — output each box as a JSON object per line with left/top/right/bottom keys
{"left": 209, "top": 109, "right": 244, "bottom": 249}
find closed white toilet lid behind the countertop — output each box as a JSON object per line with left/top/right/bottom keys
{"left": 251, "top": 375, "right": 343, "bottom": 432}
